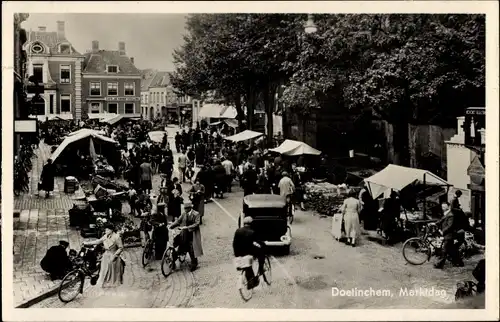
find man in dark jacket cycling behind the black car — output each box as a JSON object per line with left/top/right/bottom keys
{"left": 233, "top": 217, "right": 265, "bottom": 289}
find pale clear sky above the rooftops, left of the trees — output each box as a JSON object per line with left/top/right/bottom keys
{"left": 22, "top": 13, "right": 185, "bottom": 71}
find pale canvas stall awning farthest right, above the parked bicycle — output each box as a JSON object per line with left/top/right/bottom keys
{"left": 365, "top": 164, "right": 450, "bottom": 199}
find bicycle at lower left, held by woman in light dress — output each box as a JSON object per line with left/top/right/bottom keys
{"left": 58, "top": 246, "right": 102, "bottom": 303}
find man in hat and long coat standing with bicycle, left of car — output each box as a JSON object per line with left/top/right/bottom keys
{"left": 170, "top": 202, "right": 203, "bottom": 271}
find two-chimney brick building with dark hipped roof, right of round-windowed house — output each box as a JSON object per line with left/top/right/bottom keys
{"left": 82, "top": 40, "right": 142, "bottom": 118}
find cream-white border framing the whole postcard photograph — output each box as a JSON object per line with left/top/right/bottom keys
{"left": 2, "top": 1, "right": 499, "bottom": 321}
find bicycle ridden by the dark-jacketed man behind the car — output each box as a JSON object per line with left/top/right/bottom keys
{"left": 234, "top": 255, "right": 272, "bottom": 302}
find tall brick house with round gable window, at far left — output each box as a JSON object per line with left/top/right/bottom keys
{"left": 25, "top": 21, "right": 84, "bottom": 120}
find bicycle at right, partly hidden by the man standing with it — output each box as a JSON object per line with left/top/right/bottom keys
{"left": 403, "top": 224, "right": 474, "bottom": 265}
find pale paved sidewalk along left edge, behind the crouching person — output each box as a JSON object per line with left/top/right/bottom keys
{"left": 13, "top": 143, "right": 83, "bottom": 306}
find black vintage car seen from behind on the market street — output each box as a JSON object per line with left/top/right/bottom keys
{"left": 238, "top": 194, "right": 292, "bottom": 254}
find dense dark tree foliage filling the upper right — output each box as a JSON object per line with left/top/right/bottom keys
{"left": 172, "top": 14, "right": 485, "bottom": 132}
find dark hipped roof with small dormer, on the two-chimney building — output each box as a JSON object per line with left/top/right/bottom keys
{"left": 83, "top": 50, "right": 141, "bottom": 76}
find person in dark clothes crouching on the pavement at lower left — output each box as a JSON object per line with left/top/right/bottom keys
{"left": 40, "top": 240, "right": 73, "bottom": 280}
